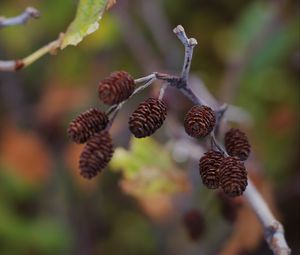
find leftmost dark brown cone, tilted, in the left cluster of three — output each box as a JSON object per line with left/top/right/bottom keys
{"left": 68, "top": 108, "right": 108, "bottom": 143}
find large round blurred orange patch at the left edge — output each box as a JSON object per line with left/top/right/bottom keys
{"left": 0, "top": 124, "right": 52, "bottom": 183}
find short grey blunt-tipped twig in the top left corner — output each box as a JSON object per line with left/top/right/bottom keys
{"left": 0, "top": 7, "right": 40, "bottom": 28}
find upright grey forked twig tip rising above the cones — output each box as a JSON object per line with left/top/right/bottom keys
{"left": 173, "top": 25, "right": 198, "bottom": 82}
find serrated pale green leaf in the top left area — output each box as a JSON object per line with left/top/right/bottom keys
{"left": 60, "top": 0, "right": 108, "bottom": 49}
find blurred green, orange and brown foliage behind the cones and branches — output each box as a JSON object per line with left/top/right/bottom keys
{"left": 0, "top": 0, "right": 300, "bottom": 255}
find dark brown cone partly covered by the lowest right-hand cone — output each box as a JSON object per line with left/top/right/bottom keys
{"left": 199, "top": 150, "right": 224, "bottom": 189}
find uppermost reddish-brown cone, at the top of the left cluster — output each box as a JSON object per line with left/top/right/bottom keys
{"left": 98, "top": 71, "right": 134, "bottom": 105}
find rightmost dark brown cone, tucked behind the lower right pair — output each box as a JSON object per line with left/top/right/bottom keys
{"left": 225, "top": 128, "right": 250, "bottom": 161}
